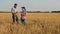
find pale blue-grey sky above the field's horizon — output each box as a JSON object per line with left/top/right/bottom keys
{"left": 0, "top": 0, "right": 60, "bottom": 11}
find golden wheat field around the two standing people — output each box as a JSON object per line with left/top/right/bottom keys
{"left": 0, "top": 13, "right": 60, "bottom": 34}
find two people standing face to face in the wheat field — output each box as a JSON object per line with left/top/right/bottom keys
{"left": 11, "top": 3, "right": 26, "bottom": 25}
